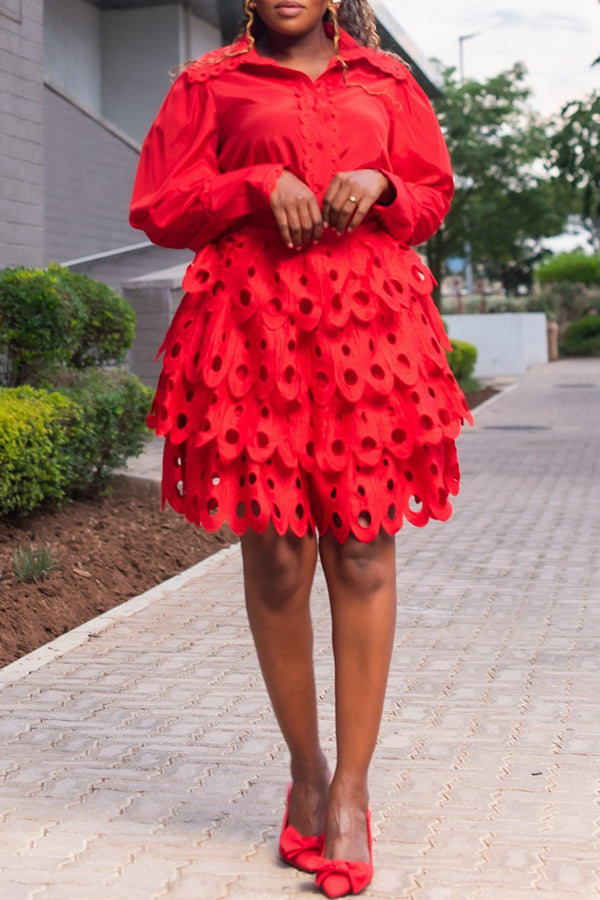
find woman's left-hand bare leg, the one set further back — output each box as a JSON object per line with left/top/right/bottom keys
{"left": 242, "top": 526, "right": 329, "bottom": 835}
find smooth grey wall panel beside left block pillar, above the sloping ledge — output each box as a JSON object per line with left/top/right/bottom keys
{"left": 44, "top": 0, "right": 102, "bottom": 114}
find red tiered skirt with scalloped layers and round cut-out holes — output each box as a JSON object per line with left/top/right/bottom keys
{"left": 148, "top": 223, "right": 472, "bottom": 542}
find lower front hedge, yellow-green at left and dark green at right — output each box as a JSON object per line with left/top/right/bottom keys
{"left": 0, "top": 371, "right": 152, "bottom": 516}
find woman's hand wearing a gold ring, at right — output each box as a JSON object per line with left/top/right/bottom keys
{"left": 323, "top": 169, "right": 390, "bottom": 234}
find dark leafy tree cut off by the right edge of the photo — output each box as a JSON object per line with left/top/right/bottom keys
{"left": 548, "top": 91, "right": 600, "bottom": 251}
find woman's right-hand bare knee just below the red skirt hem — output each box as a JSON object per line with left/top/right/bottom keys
{"left": 320, "top": 533, "right": 395, "bottom": 597}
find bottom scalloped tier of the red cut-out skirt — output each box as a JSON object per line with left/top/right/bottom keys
{"left": 162, "top": 437, "right": 460, "bottom": 543}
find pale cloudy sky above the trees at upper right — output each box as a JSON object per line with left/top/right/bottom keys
{"left": 386, "top": 0, "right": 600, "bottom": 116}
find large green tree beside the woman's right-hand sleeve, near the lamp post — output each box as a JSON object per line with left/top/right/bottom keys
{"left": 427, "top": 63, "right": 569, "bottom": 302}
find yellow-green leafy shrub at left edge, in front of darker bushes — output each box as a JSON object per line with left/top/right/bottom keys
{"left": 0, "top": 387, "right": 79, "bottom": 516}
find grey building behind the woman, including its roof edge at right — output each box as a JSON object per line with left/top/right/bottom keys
{"left": 0, "top": 0, "right": 440, "bottom": 382}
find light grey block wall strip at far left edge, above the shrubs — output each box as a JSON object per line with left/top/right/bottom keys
{"left": 0, "top": 0, "right": 44, "bottom": 267}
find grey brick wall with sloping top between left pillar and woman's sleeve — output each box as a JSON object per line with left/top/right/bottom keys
{"left": 44, "top": 87, "right": 146, "bottom": 262}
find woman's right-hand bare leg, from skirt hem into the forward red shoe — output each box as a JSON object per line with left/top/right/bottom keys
{"left": 320, "top": 532, "right": 396, "bottom": 861}
